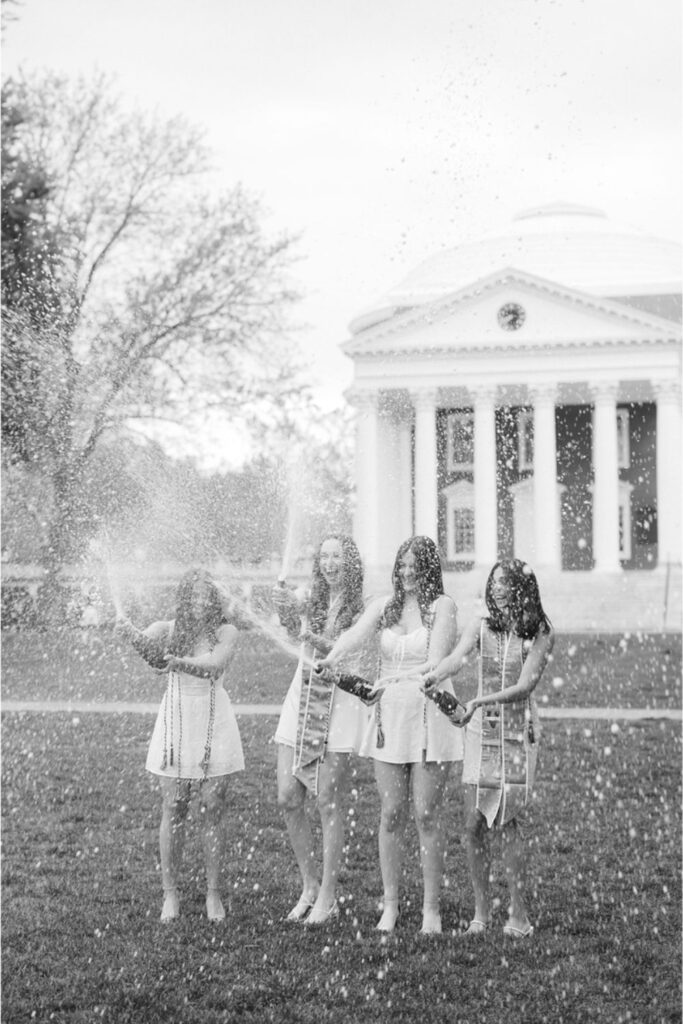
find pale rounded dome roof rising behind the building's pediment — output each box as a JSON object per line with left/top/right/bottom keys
{"left": 350, "top": 203, "right": 681, "bottom": 334}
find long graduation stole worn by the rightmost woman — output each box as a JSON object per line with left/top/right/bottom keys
{"left": 476, "top": 621, "right": 535, "bottom": 827}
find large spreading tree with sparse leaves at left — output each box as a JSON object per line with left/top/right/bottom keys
{"left": 2, "top": 73, "right": 302, "bottom": 618}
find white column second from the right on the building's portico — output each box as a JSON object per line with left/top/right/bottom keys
{"left": 593, "top": 384, "right": 621, "bottom": 572}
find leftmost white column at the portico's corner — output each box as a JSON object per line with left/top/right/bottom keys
{"left": 349, "top": 391, "right": 379, "bottom": 566}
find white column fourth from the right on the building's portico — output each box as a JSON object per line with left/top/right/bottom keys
{"left": 473, "top": 388, "right": 498, "bottom": 567}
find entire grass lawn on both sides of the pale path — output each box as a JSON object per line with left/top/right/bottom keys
{"left": 2, "top": 634, "right": 681, "bottom": 1024}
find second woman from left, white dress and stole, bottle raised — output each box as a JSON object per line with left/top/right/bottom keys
{"left": 272, "top": 535, "right": 368, "bottom": 926}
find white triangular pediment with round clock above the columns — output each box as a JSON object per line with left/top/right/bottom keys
{"left": 343, "top": 268, "right": 681, "bottom": 358}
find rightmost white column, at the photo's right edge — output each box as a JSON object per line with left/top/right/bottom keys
{"left": 654, "top": 381, "right": 681, "bottom": 565}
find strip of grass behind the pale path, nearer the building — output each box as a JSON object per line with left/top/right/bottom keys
{"left": 2, "top": 629, "right": 681, "bottom": 708}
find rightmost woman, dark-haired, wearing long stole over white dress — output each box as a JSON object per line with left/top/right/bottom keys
{"left": 424, "top": 558, "right": 555, "bottom": 938}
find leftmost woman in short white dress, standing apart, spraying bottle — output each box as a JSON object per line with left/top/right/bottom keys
{"left": 117, "top": 568, "right": 244, "bottom": 923}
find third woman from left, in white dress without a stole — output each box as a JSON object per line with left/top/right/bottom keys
{"left": 321, "top": 537, "right": 463, "bottom": 934}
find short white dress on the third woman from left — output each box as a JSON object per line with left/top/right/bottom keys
{"left": 360, "top": 626, "right": 463, "bottom": 764}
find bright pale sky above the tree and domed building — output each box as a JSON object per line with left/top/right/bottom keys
{"left": 3, "top": 0, "right": 683, "bottom": 423}
